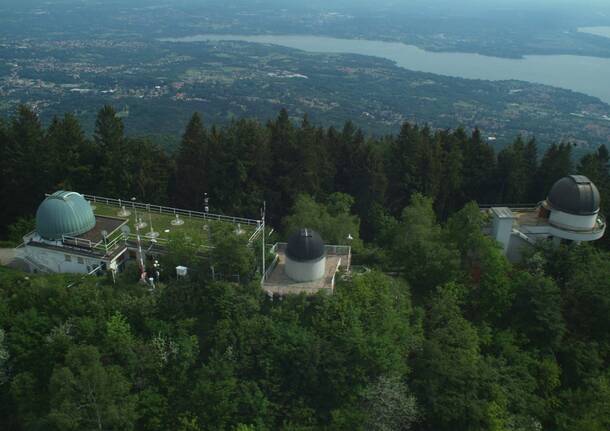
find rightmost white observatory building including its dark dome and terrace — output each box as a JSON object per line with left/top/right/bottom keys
{"left": 484, "top": 175, "right": 606, "bottom": 261}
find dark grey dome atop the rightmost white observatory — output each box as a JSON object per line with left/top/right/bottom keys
{"left": 547, "top": 175, "right": 600, "bottom": 215}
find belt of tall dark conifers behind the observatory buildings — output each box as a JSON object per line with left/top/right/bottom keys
{"left": 0, "top": 106, "right": 610, "bottom": 241}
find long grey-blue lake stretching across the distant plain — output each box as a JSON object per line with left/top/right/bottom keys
{"left": 161, "top": 34, "right": 610, "bottom": 103}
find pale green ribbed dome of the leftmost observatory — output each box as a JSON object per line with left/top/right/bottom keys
{"left": 36, "top": 190, "right": 95, "bottom": 240}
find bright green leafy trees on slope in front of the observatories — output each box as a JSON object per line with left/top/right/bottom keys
{"left": 0, "top": 203, "right": 610, "bottom": 431}
